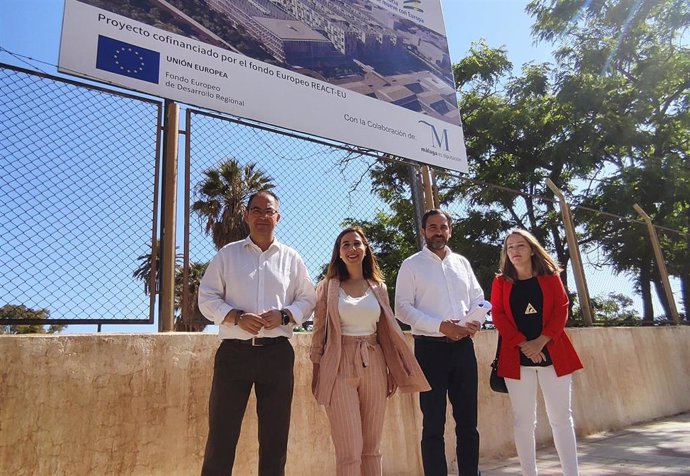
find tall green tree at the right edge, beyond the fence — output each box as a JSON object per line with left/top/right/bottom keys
{"left": 527, "top": 0, "right": 690, "bottom": 320}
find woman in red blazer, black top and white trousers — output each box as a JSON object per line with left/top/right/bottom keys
{"left": 491, "top": 229, "right": 582, "bottom": 476}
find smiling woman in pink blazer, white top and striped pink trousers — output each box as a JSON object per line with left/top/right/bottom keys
{"left": 310, "top": 228, "right": 430, "bottom": 476}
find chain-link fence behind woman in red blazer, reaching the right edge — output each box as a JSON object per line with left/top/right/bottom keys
{"left": 438, "top": 176, "right": 688, "bottom": 326}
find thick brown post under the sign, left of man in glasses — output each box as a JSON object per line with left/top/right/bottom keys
{"left": 158, "top": 100, "right": 180, "bottom": 332}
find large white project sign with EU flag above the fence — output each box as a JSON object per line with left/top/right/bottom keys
{"left": 59, "top": 0, "right": 467, "bottom": 172}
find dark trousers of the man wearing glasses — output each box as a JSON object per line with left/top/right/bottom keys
{"left": 201, "top": 338, "right": 295, "bottom": 476}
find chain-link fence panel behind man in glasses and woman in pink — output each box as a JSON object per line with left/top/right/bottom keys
{"left": 176, "top": 110, "right": 396, "bottom": 329}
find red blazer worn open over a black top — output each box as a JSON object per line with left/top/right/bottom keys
{"left": 491, "top": 275, "right": 582, "bottom": 379}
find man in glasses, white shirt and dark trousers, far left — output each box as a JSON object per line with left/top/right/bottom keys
{"left": 199, "top": 191, "right": 316, "bottom": 476}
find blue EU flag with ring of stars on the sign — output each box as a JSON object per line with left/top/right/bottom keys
{"left": 96, "top": 35, "right": 161, "bottom": 84}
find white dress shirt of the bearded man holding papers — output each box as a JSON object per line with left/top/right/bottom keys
{"left": 395, "top": 246, "right": 484, "bottom": 337}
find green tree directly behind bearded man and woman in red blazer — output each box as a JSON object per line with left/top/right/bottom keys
{"left": 448, "top": 42, "right": 599, "bottom": 302}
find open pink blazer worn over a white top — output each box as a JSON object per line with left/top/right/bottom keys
{"left": 310, "top": 279, "right": 431, "bottom": 405}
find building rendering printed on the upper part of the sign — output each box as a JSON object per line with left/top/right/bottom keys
{"left": 208, "top": 0, "right": 460, "bottom": 124}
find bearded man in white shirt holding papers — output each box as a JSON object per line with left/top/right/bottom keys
{"left": 395, "top": 209, "right": 484, "bottom": 476}
